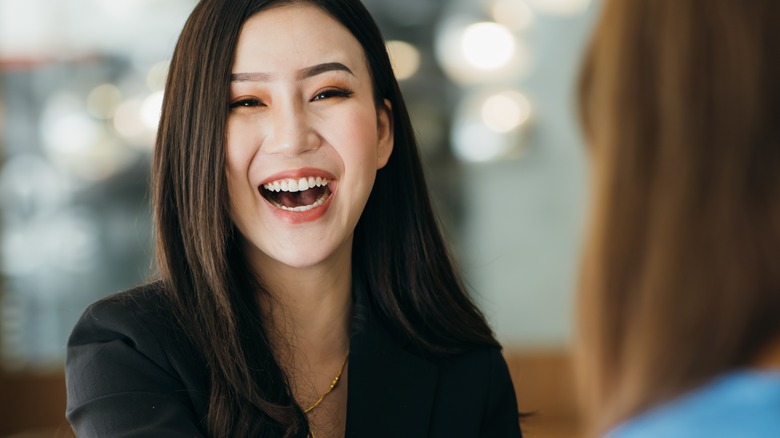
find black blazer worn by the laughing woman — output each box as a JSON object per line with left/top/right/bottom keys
{"left": 65, "top": 278, "right": 521, "bottom": 438}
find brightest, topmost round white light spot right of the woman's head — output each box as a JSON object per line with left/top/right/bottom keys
{"left": 461, "top": 22, "right": 515, "bottom": 70}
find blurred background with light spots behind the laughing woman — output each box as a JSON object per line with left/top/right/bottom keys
{"left": 0, "top": 0, "right": 598, "bottom": 437}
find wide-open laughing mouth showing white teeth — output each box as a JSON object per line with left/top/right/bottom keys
{"left": 259, "top": 176, "right": 331, "bottom": 212}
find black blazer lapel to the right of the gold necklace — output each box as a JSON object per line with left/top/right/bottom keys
{"left": 346, "top": 275, "right": 438, "bottom": 438}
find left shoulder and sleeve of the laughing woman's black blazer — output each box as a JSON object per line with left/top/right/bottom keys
{"left": 65, "top": 283, "right": 208, "bottom": 437}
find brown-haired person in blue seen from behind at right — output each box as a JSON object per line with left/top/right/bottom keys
{"left": 579, "top": 0, "right": 780, "bottom": 438}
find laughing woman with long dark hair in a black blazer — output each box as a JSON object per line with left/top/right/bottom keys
{"left": 66, "top": 0, "right": 520, "bottom": 438}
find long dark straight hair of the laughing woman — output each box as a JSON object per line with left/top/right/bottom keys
{"left": 152, "top": 0, "right": 498, "bottom": 437}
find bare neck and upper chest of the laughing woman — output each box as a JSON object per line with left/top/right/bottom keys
{"left": 258, "top": 251, "right": 352, "bottom": 428}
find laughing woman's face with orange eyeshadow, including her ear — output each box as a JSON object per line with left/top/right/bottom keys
{"left": 227, "top": 3, "right": 393, "bottom": 274}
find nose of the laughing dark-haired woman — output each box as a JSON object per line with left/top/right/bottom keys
{"left": 264, "top": 102, "right": 320, "bottom": 155}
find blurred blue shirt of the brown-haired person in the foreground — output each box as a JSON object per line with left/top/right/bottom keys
{"left": 607, "top": 370, "right": 780, "bottom": 438}
